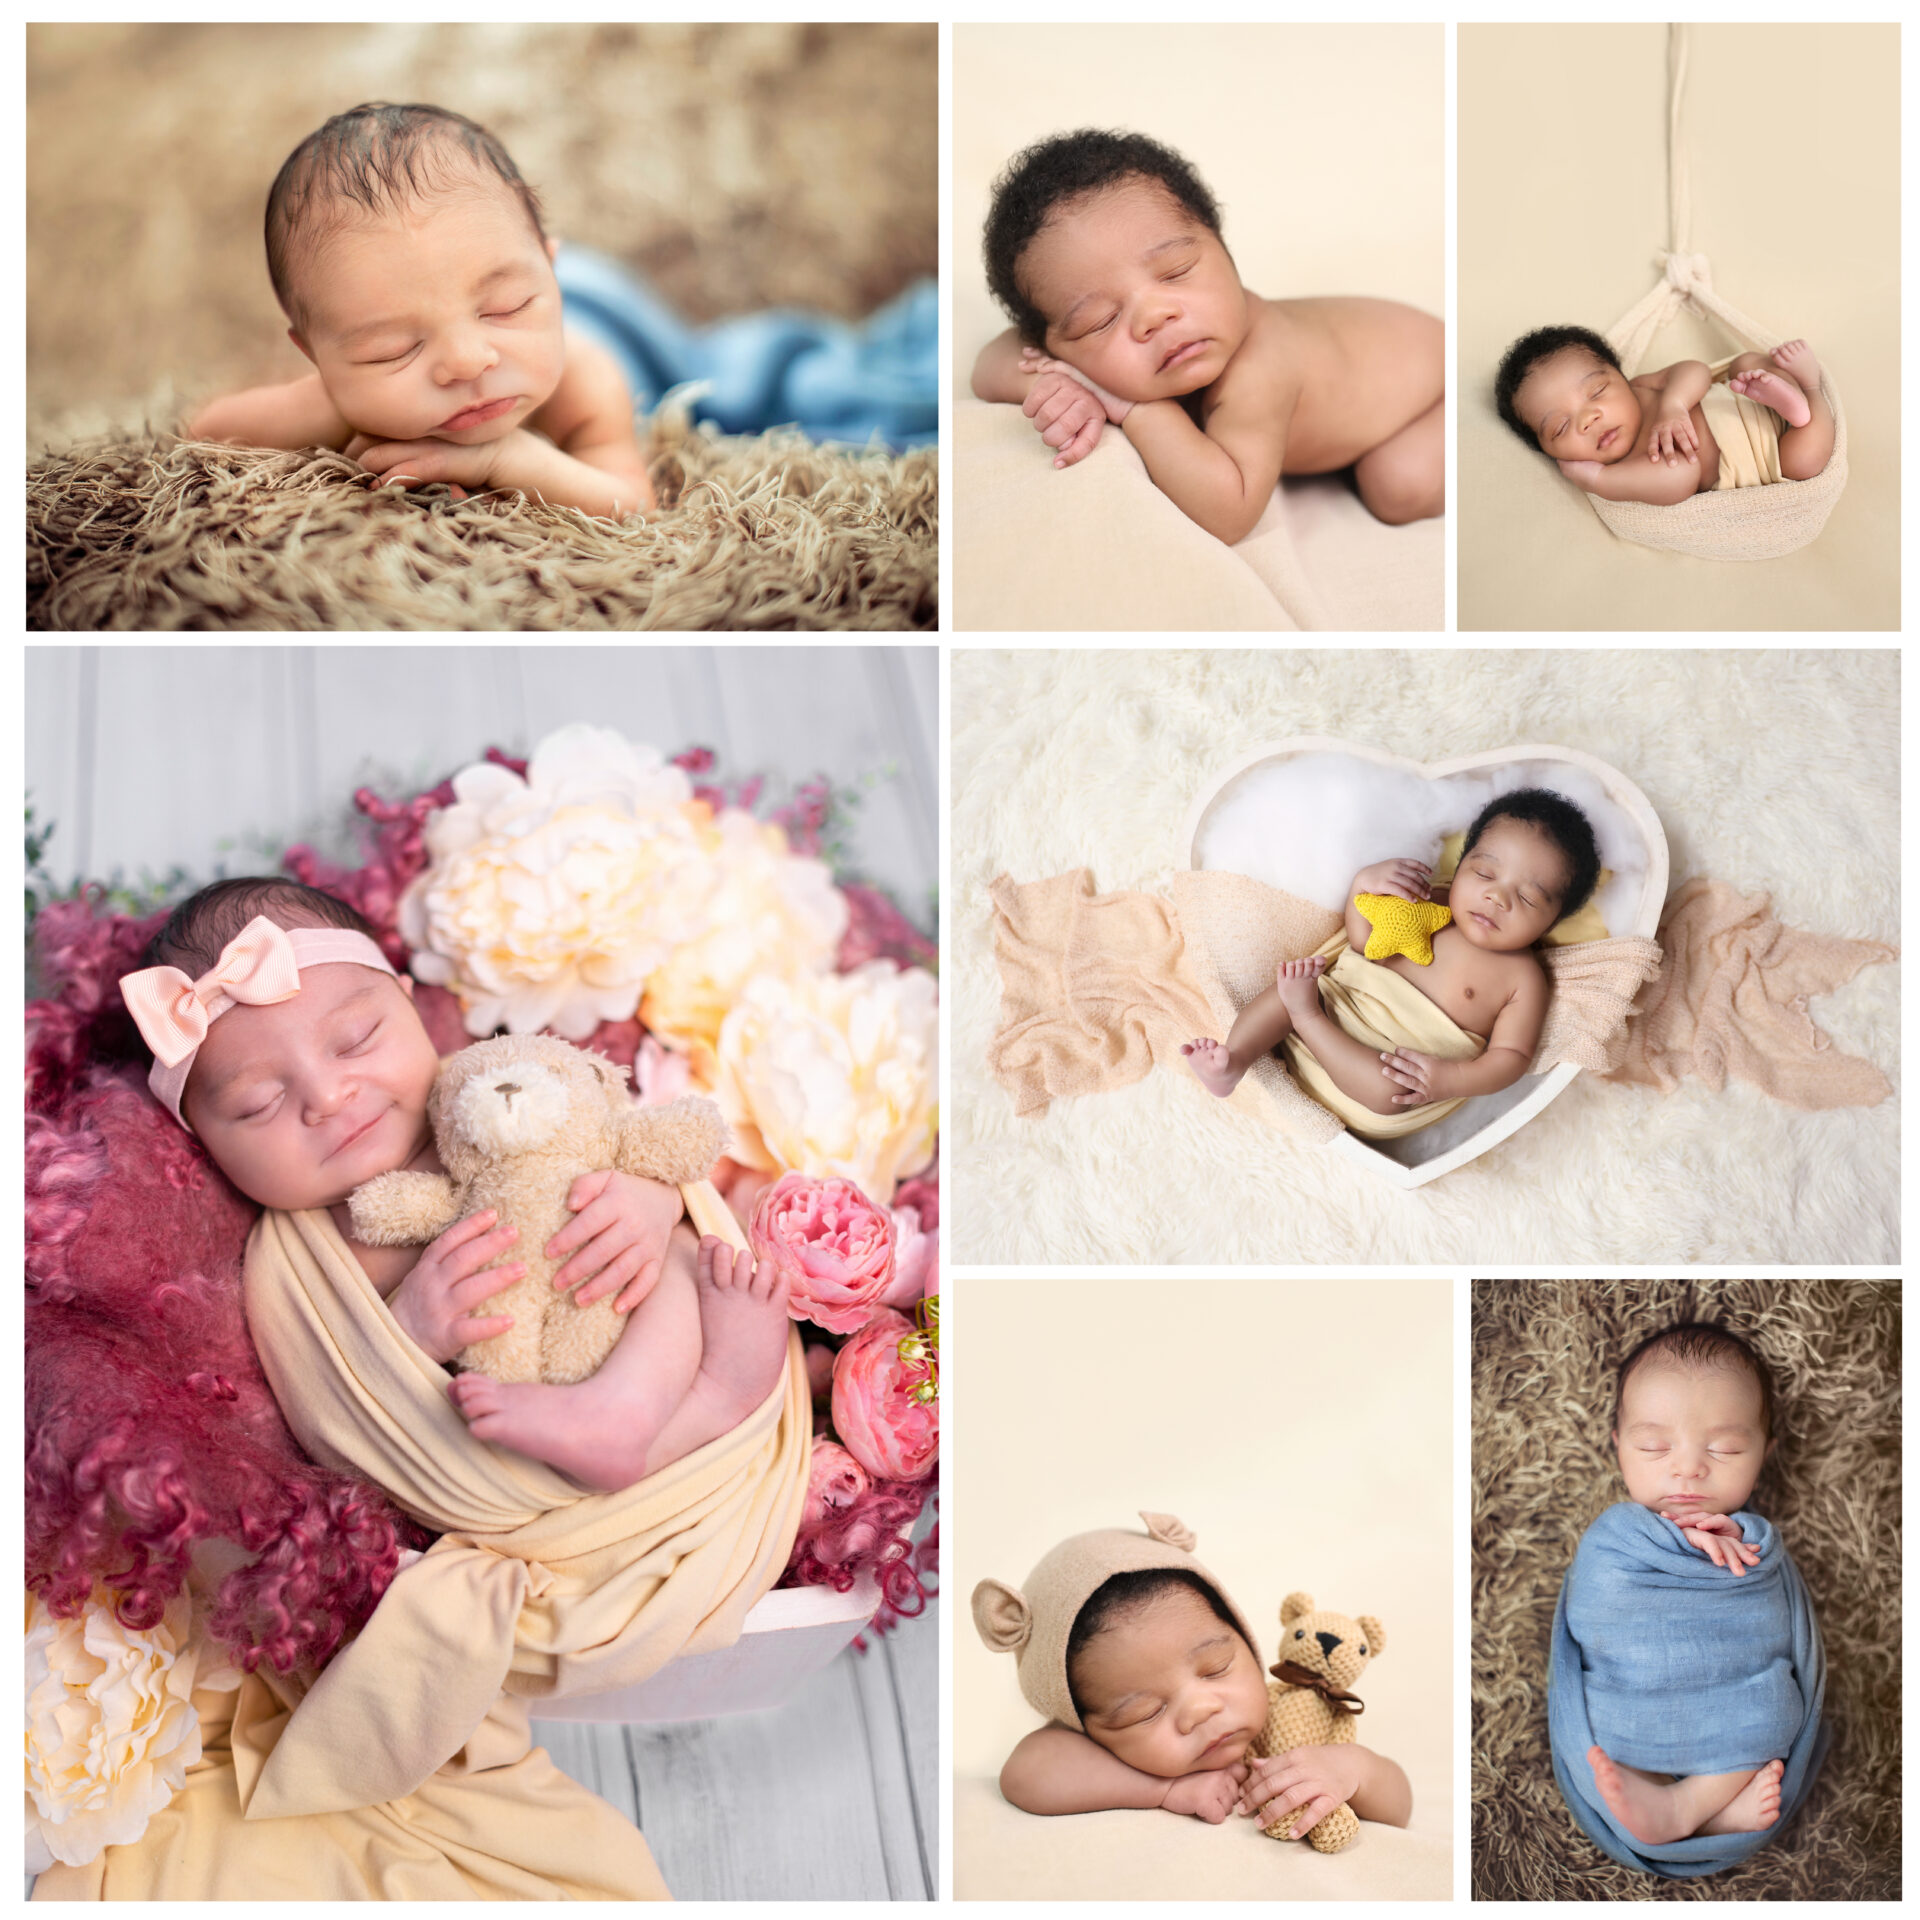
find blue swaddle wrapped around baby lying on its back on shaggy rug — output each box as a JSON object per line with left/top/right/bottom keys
{"left": 1548, "top": 1501, "right": 1826, "bottom": 1880}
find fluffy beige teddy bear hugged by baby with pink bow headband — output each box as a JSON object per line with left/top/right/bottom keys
{"left": 348, "top": 1033, "right": 726, "bottom": 1384}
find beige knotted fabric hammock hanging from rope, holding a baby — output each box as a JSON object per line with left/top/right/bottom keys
{"left": 1588, "top": 25, "right": 1847, "bottom": 561}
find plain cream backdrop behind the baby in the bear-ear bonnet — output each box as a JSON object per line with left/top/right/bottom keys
{"left": 947, "top": 1277, "right": 1453, "bottom": 1897}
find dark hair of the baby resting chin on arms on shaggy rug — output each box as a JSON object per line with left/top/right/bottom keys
{"left": 267, "top": 100, "right": 547, "bottom": 326}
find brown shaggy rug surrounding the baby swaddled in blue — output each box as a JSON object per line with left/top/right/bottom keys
{"left": 1473, "top": 1279, "right": 1901, "bottom": 1901}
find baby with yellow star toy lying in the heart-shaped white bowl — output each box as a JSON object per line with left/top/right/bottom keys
{"left": 1181, "top": 787, "right": 1599, "bottom": 1140}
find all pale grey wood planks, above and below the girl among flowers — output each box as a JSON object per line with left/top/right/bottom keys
{"left": 27, "top": 645, "right": 939, "bottom": 1899}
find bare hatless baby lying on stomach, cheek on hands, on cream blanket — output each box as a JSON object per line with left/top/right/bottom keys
{"left": 973, "top": 131, "right": 1446, "bottom": 543}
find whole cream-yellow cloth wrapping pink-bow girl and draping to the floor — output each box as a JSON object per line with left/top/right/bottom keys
{"left": 36, "top": 1212, "right": 812, "bottom": 1899}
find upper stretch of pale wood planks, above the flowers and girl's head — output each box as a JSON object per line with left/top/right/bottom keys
{"left": 27, "top": 645, "right": 939, "bottom": 929}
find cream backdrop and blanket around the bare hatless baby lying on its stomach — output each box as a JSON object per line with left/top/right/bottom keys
{"left": 950, "top": 25, "right": 1446, "bottom": 630}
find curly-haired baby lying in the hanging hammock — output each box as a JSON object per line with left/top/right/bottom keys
{"left": 1494, "top": 326, "right": 1834, "bottom": 507}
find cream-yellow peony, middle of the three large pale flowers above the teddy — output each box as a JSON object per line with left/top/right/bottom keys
{"left": 639, "top": 808, "right": 847, "bottom": 1087}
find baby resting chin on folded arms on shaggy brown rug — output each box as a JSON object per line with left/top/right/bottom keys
{"left": 186, "top": 104, "right": 653, "bottom": 518}
